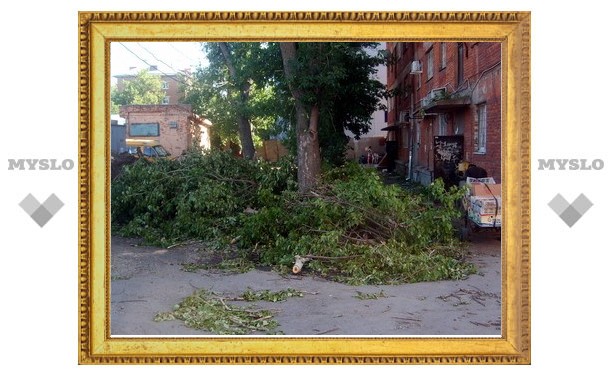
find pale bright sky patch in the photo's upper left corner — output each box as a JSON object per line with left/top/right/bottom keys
{"left": 111, "top": 42, "right": 210, "bottom": 77}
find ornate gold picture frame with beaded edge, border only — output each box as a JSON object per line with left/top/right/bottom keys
{"left": 79, "top": 11, "right": 531, "bottom": 364}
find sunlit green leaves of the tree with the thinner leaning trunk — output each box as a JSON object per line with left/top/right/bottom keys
{"left": 183, "top": 42, "right": 289, "bottom": 152}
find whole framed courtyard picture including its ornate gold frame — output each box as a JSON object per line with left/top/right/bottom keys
{"left": 79, "top": 12, "right": 530, "bottom": 364}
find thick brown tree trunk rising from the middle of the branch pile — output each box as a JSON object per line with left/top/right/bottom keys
{"left": 280, "top": 42, "right": 321, "bottom": 193}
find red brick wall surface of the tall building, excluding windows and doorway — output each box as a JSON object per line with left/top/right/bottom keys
{"left": 388, "top": 42, "right": 502, "bottom": 182}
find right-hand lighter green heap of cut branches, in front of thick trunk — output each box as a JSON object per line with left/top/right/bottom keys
{"left": 235, "top": 164, "right": 473, "bottom": 284}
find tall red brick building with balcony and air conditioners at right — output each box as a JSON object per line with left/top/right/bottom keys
{"left": 387, "top": 42, "right": 502, "bottom": 184}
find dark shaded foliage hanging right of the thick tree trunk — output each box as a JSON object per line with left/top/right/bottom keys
{"left": 280, "top": 42, "right": 385, "bottom": 166}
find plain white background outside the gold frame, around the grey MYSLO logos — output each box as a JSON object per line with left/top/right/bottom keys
{"left": 0, "top": 0, "right": 612, "bottom": 377}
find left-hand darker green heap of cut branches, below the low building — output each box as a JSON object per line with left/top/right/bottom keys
{"left": 111, "top": 150, "right": 296, "bottom": 245}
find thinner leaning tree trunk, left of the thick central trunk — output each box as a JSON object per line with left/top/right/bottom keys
{"left": 219, "top": 42, "right": 255, "bottom": 159}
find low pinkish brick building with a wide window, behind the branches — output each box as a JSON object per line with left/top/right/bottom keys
{"left": 121, "top": 105, "right": 210, "bottom": 156}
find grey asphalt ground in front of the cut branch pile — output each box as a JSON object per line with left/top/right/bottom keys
{"left": 111, "top": 232, "right": 501, "bottom": 336}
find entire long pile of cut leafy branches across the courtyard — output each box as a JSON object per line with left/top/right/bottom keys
{"left": 111, "top": 152, "right": 475, "bottom": 285}
